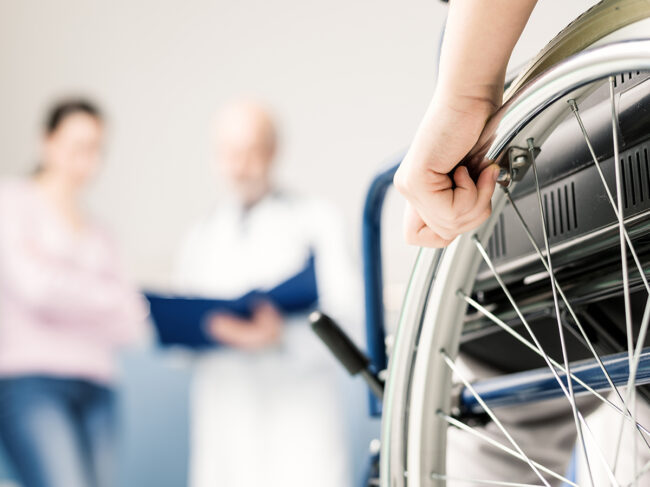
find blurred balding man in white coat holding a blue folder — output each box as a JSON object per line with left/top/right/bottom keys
{"left": 178, "top": 101, "right": 360, "bottom": 487}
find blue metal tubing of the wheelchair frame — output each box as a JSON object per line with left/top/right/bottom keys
{"left": 362, "top": 163, "right": 650, "bottom": 417}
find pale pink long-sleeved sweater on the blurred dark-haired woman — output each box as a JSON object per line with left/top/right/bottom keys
{"left": 0, "top": 180, "right": 146, "bottom": 383}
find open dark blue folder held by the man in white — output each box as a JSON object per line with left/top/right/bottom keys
{"left": 144, "top": 255, "right": 318, "bottom": 349}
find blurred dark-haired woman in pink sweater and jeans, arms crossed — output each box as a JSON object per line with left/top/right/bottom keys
{"left": 0, "top": 100, "right": 145, "bottom": 487}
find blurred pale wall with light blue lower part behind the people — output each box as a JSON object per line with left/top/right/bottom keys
{"left": 0, "top": 0, "right": 593, "bottom": 487}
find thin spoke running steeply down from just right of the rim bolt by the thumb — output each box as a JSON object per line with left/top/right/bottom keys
{"left": 527, "top": 138, "right": 594, "bottom": 487}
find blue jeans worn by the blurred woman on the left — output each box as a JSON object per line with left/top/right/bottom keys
{"left": 0, "top": 376, "right": 114, "bottom": 487}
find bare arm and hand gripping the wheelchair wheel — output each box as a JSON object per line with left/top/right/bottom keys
{"left": 395, "top": 0, "right": 536, "bottom": 247}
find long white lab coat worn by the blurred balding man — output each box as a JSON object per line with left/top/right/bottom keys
{"left": 178, "top": 194, "right": 361, "bottom": 487}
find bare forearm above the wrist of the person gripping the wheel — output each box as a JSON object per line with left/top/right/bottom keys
{"left": 434, "top": 0, "right": 536, "bottom": 112}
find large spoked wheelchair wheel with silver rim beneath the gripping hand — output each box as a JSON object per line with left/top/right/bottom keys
{"left": 380, "top": 1, "right": 650, "bottom": 487}
